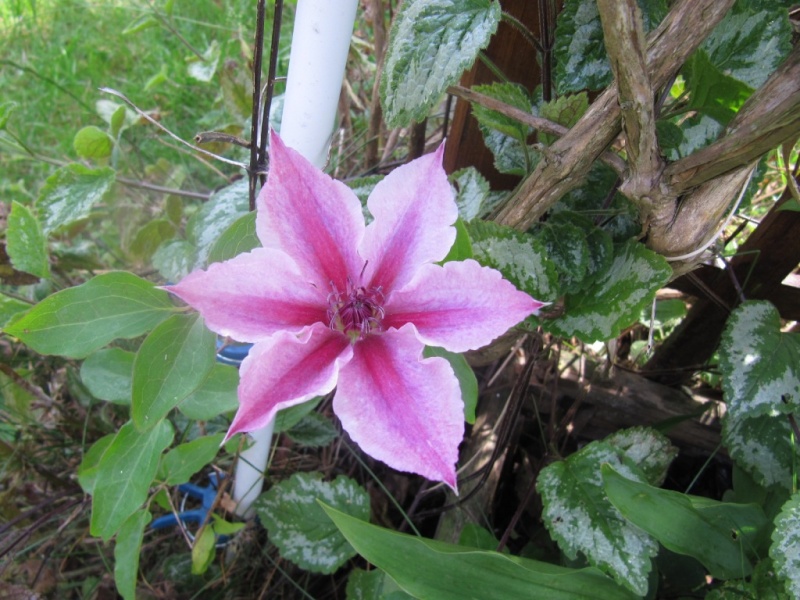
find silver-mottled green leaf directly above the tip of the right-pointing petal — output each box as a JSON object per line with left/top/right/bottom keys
{"left": 467, "top": 221, "right": 560, "bottom": 302}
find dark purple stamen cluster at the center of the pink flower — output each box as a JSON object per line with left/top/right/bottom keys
{"left": 328, "top": 277, "right": 384, "bottom": 342}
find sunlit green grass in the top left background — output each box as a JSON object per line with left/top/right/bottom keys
{"left": 0, "top": 0, "right": 268, "bottom": 202}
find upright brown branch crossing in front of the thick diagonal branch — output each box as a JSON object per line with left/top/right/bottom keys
{"left": 597, "top": 0, "right": 663, "bottom": 201}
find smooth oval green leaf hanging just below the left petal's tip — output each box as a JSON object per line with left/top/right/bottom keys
{"left": 131, "top": 315, "right": 216, "bottom": 430}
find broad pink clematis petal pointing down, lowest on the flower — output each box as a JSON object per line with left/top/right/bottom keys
{"left": 333, "top": 327, "right": 464, "bottom": 490}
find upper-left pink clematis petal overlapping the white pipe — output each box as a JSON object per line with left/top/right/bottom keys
{"left": 256, "top": 132, "right": 364, "bottom": 293}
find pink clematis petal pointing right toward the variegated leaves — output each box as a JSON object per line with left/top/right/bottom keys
{"left": 383, "top": 260, "right": 544, "bottom": 352}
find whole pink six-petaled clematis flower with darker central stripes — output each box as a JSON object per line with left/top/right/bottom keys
{"left": 167, "top": 133, "right": 542, "bottom": 489}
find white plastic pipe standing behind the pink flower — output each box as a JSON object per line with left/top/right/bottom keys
{"left": 233, "top": 0, "right": 358, "bottom": 516}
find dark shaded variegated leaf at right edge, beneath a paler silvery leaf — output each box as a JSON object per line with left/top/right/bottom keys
{"left": 722, "top": 413, "right": 800, "bottom": 490}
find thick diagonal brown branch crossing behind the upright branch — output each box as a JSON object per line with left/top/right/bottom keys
{"left": 494, "top": 0, "right": 734, "bottom": 230}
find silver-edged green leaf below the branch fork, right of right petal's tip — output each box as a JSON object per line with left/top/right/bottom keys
{"left": 547, "top": 241, "right": 672, "bottom": 343}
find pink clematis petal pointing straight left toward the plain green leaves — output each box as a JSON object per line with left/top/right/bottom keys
{"left": 165, "top": 248, "right": 327, "bottom": 342}
